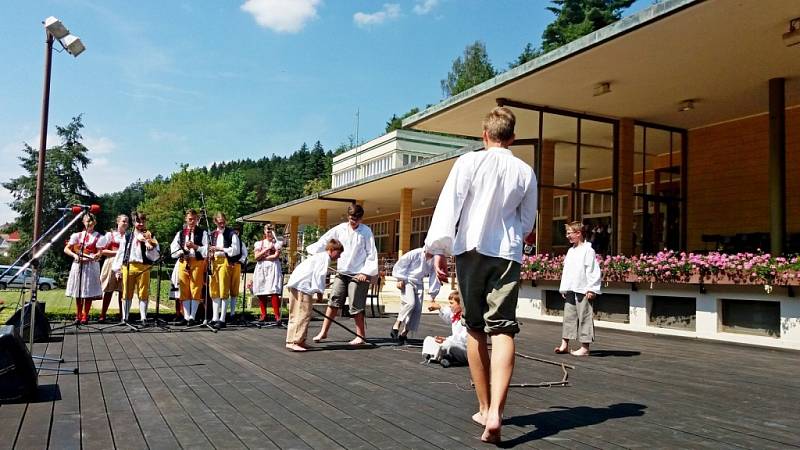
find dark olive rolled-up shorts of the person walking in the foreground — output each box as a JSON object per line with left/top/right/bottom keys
{"left": 456, "top": 250, "right": 520, "bottom": 334}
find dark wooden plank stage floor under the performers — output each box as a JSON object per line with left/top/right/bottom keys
{"left": 0, "top": 315, "right": 800, "bottom": 449}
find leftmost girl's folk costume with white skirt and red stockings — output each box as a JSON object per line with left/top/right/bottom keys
{"left": 65, "top": 230, "right": 106, "bottom": 324}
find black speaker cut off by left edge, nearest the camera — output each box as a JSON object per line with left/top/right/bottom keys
{"left": 0, "top": 325, "right": 37, "bottom": 402}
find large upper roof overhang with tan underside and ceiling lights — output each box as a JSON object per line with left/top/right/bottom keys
{"left": 403, "top": 0, "right": 800, "bottom": 138}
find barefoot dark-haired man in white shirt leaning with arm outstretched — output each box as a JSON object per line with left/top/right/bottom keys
{"left": 306, "top": 204, "right": 378, "bottom": 345}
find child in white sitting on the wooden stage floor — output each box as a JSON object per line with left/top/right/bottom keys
{"left": 422, "top": 291, "right": 467, "bottom": 367}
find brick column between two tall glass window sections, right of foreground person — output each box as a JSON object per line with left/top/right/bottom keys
{"left": 614, "top": 119, "right": 635, "bottom": 255}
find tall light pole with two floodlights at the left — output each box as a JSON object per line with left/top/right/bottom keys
{"left": 33, "top": 16, "right": 86, "bottom": 242}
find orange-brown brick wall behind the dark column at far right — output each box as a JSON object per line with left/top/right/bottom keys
{"left": 687, "top": 108, "right": 800, "bottom": 250}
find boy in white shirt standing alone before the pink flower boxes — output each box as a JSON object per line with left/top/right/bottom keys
{"left": 554, "top": 222, "right": 603, "bottom": 356}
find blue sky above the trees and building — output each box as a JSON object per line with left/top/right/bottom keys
{"left": 0, "top": 0, "right": 653, "bottom": 224}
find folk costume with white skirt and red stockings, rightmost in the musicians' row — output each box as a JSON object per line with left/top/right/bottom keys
{"left": 253, "top": 239, "right": 283, "bottom": 322}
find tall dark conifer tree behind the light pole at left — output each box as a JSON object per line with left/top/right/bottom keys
{"left": 3, "top": 115, "right": 97, "bottom": 272}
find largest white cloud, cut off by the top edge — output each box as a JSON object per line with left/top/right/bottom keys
{"left": 241, "top": 0, "right": 322, "bottom": 33}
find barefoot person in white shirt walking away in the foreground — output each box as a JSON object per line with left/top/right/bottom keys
{"left": 425, "top": 107, "right": 537, "bottom": 443}
